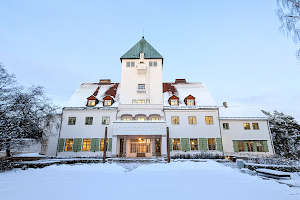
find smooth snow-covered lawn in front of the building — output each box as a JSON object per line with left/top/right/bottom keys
{"left": 0, "top": 160, "right": 300, "bottom": 200}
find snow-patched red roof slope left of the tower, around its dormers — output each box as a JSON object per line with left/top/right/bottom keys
{"left": 65, "top": 83, "right": 119, "bottom": 107}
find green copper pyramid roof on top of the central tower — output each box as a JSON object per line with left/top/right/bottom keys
{"left": 120, "top": 37, "right": 163, "bottom": 60}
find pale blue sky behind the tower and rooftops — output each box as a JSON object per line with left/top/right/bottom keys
{"left": 0, "top": 0, "right": 300, "bottom": 122}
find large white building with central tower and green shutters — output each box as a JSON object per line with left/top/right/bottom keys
{"left": 47, "top": 38, "right": 273, "bottom": 158}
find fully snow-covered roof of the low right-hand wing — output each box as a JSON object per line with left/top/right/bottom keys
{"left": 219, "top": 106, "right": 267, "bottom": 119}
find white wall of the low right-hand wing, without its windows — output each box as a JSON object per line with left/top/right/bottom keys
{"left": 220, "top": 119, "right": 273, "bottom": 156}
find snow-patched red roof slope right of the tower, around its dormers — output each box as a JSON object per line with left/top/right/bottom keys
{"left": 163, "top": 82, "right": 217, "bottom": 107}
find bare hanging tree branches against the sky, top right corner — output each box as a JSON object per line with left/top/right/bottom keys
{"left": 276, "top": 0, "right": 300, "bottom": 59}
